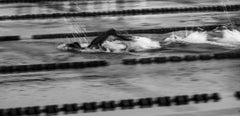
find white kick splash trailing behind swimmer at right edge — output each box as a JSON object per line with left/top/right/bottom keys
{"left": 163, "top": 29, "right": 240, "bottom": 48}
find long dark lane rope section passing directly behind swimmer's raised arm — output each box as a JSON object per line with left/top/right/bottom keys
{"left": 31, "top": 24, "right": 240, "bottom": 39}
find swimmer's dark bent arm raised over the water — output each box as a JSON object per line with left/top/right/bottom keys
{"left": 88, "top": 29, "right": 131, "bottom": 48}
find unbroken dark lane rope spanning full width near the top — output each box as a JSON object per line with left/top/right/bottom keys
{"left": 0, "top": 4, "right": 240, "bottom": 21}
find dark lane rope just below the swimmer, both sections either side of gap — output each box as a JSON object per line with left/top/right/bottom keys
{"left": 0, "top": 52, "right": 240, "bottom": 74}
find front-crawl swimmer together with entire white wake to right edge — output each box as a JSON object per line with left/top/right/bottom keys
{"left": 58, "top": 26, "right": 240, "bottom": 53}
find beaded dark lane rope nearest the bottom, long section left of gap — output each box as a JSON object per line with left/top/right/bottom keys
{"left": 0, "top": 93, "right": 222, "bottom": 116}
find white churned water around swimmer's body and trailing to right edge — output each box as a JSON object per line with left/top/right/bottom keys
{"left": 58, "top": 28, "right": 240, "bottom": 53}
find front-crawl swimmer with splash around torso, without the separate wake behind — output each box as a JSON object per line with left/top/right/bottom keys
{"left": 58, "top": 29, "right": 161, "bottom": 52}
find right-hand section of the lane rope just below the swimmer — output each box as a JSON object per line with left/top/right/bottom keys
{"left": 122, "top": 52, "right": 240, "bottom": 65}
